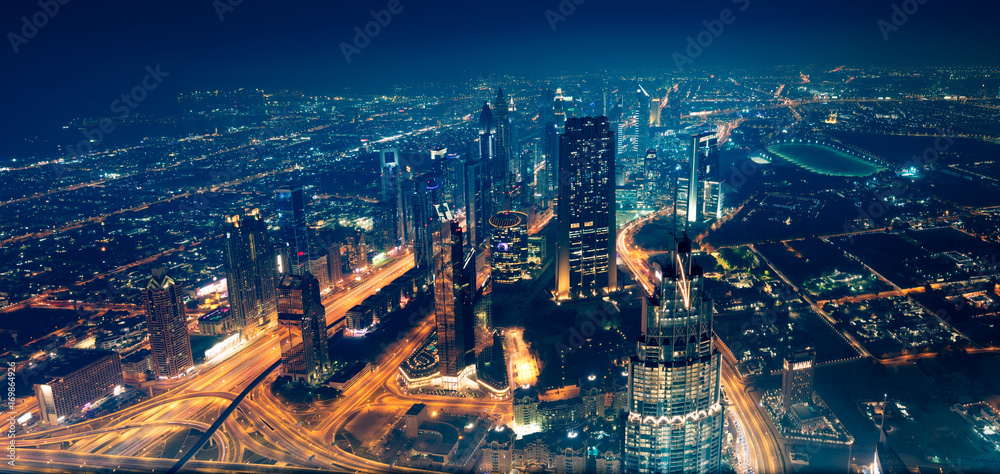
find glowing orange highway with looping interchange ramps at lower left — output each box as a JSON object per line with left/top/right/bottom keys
{"left": 17, "top": 254, "right": 416, "bottom": 471}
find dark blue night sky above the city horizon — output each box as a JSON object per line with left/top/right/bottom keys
{"left": 0, "top": 0, "right": 1000, "bottom": 144}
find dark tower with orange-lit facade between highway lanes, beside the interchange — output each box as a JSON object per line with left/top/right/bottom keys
{"left": 278, "top": 272, "right": 331, "bottom": 384}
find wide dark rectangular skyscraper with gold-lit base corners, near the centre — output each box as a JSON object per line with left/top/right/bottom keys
{"left": 556, "top": 117, "right": 617, "bottom": 298}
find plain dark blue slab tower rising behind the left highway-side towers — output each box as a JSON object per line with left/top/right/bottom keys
{"left": 274, "top": 186, "right": 309, "bottom": 275}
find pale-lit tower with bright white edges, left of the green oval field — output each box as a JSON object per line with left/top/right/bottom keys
{"left": 677, "top": 132, "right": 722, "bottom": 223}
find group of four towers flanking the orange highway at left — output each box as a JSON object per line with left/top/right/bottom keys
{"left": 137, "top": 182, "right": 356, "bottom": 384}
